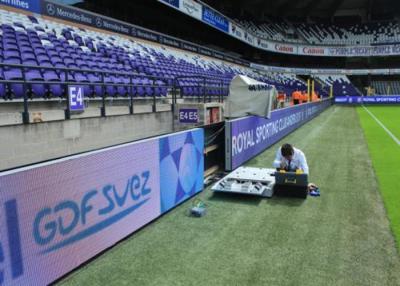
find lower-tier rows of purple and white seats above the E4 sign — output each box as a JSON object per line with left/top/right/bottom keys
{"left": 0, "top": 10, "right": 301, "bottom": 99}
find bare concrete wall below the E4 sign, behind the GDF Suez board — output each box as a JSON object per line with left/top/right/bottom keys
{"left": 0, "top": 110, "right": 173, "bottom": 170}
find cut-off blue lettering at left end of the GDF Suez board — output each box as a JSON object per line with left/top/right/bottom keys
{"left": 0, "top": 200, "right": 24, "bottom": 285}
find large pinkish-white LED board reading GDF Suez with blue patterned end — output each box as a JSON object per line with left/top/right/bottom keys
{"left": 0, "top": 129, "right": 204, "bottom": 285}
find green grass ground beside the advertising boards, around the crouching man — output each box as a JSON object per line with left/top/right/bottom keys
{"left": 59, "top": 106, "right": 400, "bottom": 286}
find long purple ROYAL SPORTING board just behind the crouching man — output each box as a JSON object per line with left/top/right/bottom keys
{"left": 225, "top": 99, "right": 332, "bottom": 170}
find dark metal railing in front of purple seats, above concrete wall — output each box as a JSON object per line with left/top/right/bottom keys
{"left": 0, "top": 63, "right": 228, "bottom": 124}
